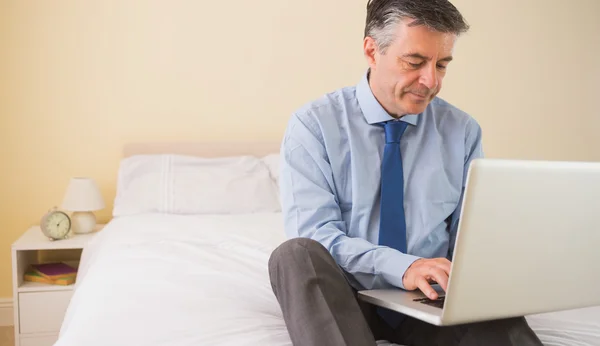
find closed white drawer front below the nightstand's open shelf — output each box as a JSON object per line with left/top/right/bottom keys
{"left": 19, "top": 290, "right": 73, "bottom": 334}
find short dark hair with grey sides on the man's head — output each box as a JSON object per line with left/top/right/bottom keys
{"left": 365, "top": 0, "right": 469, "bottom": 53}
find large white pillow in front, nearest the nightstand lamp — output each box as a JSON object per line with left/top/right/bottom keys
{"left": 113, "top": 155, "right": 281, "bottom": 217}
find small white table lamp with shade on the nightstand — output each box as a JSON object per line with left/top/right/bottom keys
{"left": 61, "top": 177, "right": 105, "bottom": 234}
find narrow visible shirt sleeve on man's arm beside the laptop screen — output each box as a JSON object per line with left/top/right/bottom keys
{"left": 448, "top": 118, "right": 484, "bottom": 261}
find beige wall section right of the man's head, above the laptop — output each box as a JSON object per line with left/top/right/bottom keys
{"left": 444, "top": 0, "right": 600, "bottom": 160}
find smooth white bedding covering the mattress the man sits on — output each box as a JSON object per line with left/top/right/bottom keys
{"left": 55, "top": 213, "right": 600, "bottom": 346}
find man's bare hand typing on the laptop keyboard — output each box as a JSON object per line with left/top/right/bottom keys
{"left": 402, "top": 258, "right": 450, "bottom": 299}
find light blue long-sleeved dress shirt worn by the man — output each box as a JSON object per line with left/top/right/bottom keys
{"left": 279, "top": 72, "right": 483, "bottom": 290}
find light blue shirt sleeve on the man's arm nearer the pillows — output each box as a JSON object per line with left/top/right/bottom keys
{"left": 279, "top": 116, "right": 419, "bottom": 289}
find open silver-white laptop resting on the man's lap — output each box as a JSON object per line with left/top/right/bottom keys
{"left": 358, "top": 159, "right": 600, "bottom": 326}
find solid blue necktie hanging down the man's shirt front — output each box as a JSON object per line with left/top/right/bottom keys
{"left": 377, "top": 120, "right": 408, "bottom": 328}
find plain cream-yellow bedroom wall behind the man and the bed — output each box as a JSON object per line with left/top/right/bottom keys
{"left": 0, "top": 0, "right": 600, "bottom": 298}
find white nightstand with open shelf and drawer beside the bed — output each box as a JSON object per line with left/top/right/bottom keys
{"left": 12, "top": 225, "right": 104, "bottom": 346}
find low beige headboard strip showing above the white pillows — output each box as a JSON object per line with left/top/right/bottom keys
{"left": 123, "top": 141, "right": 281, "bottom": 157}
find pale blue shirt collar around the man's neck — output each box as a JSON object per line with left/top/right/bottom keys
{"left": 356, "top": 71, "right": 419, "bottom": 126}
